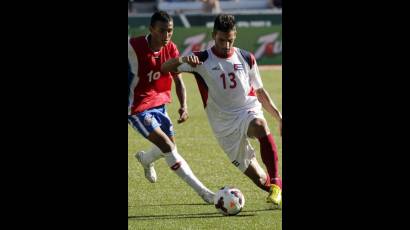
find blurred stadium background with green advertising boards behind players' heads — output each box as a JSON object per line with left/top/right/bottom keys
{"left": 128, "top": 0, "right": 282, "bottom": 65}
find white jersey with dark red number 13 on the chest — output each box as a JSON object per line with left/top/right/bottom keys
{"left": 178, "top": 48, "right": 263, "bottom": 137}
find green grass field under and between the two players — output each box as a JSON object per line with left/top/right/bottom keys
{"left": 128, "top": 70, "right": 283, "bottom": 230}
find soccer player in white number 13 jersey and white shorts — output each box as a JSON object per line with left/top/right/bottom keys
{"left": 161, "top": 15, "right": 282, "bottom": 205}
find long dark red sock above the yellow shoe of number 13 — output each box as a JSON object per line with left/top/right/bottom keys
{"left": 259, "top": 134, "right": 282, "bottom": 188}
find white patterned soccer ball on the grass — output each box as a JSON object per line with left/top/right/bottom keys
{"left": 214, "top": 186, "right": 245, "bottom": 216}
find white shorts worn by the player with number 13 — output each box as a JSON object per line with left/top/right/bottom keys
{"left": 217, "top": 109, "right": 265, "bottom": 172}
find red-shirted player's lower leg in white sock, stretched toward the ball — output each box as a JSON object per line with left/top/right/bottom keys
{"left": 143, "top": 127, "right": 214, "bottom": 204}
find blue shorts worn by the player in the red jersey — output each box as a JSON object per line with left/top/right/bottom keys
{"left": 128, "top": 105, "right": 175, "bottom": 138}
